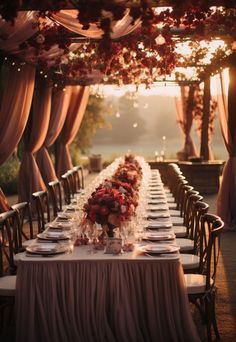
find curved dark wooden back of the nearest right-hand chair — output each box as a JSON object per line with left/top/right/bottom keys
{"left": 200, "top": 213, "right": 224, "bottom": 290}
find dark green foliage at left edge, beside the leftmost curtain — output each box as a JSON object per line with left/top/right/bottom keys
{"left": 0, "top": 156, "right": 20, "bottom": 195}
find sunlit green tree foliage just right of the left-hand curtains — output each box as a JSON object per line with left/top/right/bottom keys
{"left": 70, "top": 95, "right": 111, "bottom": 164}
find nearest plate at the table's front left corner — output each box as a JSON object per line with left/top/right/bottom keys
{"left": 26, "top": 242, "right": 68, "bottom": 254}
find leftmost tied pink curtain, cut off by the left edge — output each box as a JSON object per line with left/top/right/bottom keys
{"left": 0, "top": 63, "right": 35, "bottom": 212}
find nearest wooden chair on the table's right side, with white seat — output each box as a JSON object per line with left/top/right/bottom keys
{"left": 184, "top": 213, "right": 224, "bottom": 341}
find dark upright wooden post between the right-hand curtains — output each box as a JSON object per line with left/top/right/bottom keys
{"left": 200, "top": 78, "right": 211, "bottom": 160}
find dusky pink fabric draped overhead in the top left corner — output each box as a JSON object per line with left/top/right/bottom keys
{"left": 0, "top": 11, "right": 38, "bottom": 53}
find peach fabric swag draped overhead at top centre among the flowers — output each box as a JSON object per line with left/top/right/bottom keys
{"left": 51, "top": 9, "right": 141, "bottom": 39}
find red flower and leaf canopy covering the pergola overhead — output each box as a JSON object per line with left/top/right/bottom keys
{"left": 0, "top": 0, "right": 236, "bottom": 87}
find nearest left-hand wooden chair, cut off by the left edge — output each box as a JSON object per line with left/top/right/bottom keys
{"left": 0, "top": 210, "right": 19, "bottom": 333}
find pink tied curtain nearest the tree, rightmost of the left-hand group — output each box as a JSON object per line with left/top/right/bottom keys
{"left": 57, "top": 86, "right": 89, "bottom": 176}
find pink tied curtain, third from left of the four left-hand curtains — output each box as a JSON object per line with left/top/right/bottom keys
{"left": 36, "top": 87, "right": 71, "bottom": 184}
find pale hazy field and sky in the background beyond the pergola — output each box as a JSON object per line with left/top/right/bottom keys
{"left": 90, "top": 95, "right": 227, "bottom": 159}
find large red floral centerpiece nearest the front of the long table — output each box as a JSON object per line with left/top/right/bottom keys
{"left": 84, "top": 180, "right": 135, "bottom": 237}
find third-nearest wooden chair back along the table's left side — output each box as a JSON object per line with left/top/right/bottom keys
{"left": 32, "top": 191, "right": 50, "bottom": 233}
